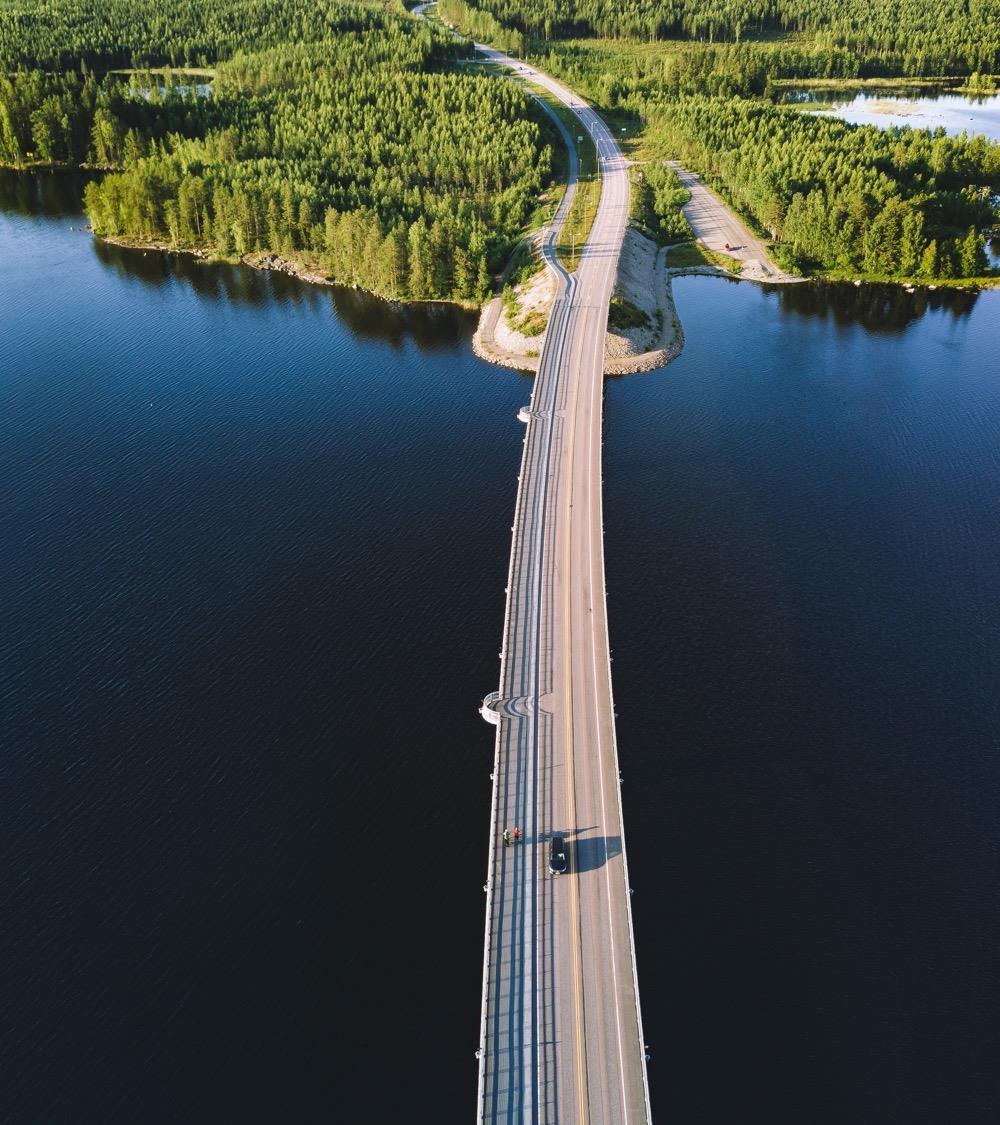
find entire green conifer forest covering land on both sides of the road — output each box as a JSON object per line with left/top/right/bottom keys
{"left": 0, "top": 0, "right": 1000, "bottom": 285}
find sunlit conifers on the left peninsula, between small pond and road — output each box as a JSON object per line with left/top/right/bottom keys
{"left": 85, "top": 23, "right": 551, "bottom": 300}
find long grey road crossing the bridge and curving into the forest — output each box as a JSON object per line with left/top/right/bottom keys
{"left": 477, "top": 45, "right": 649, "bottom": 1125}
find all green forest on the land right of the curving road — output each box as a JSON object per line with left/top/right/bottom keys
{"left": 440, "top": 0, "right": 1000, "bottom": 280}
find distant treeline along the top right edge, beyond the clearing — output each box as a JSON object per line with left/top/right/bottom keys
{"left": 452, "top": 0, "right": 1000, "bottom": 75}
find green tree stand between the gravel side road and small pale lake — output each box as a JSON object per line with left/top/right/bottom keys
{"left": 649, "top": 97, "right": 1000, "bottom": 279}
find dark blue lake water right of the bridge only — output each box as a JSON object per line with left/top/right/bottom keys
{"left": 605, "top": 278, "right": 1000, "bottom": 1125}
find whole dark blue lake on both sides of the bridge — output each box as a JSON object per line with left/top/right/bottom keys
{"left": 0, "top": 171, "right": 1000, "bottom": 1125}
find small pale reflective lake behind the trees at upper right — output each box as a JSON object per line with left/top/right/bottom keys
{"left": 785, "top": 87, "right": 1000, "bottom": 141}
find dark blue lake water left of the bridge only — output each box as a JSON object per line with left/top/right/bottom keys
{"left": 0, "top": 171, "right": 530, "bottom": 1123}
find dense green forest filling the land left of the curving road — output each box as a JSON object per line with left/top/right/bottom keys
{"left": 0, "top": 0, "right": 551, "bottom": 300}
